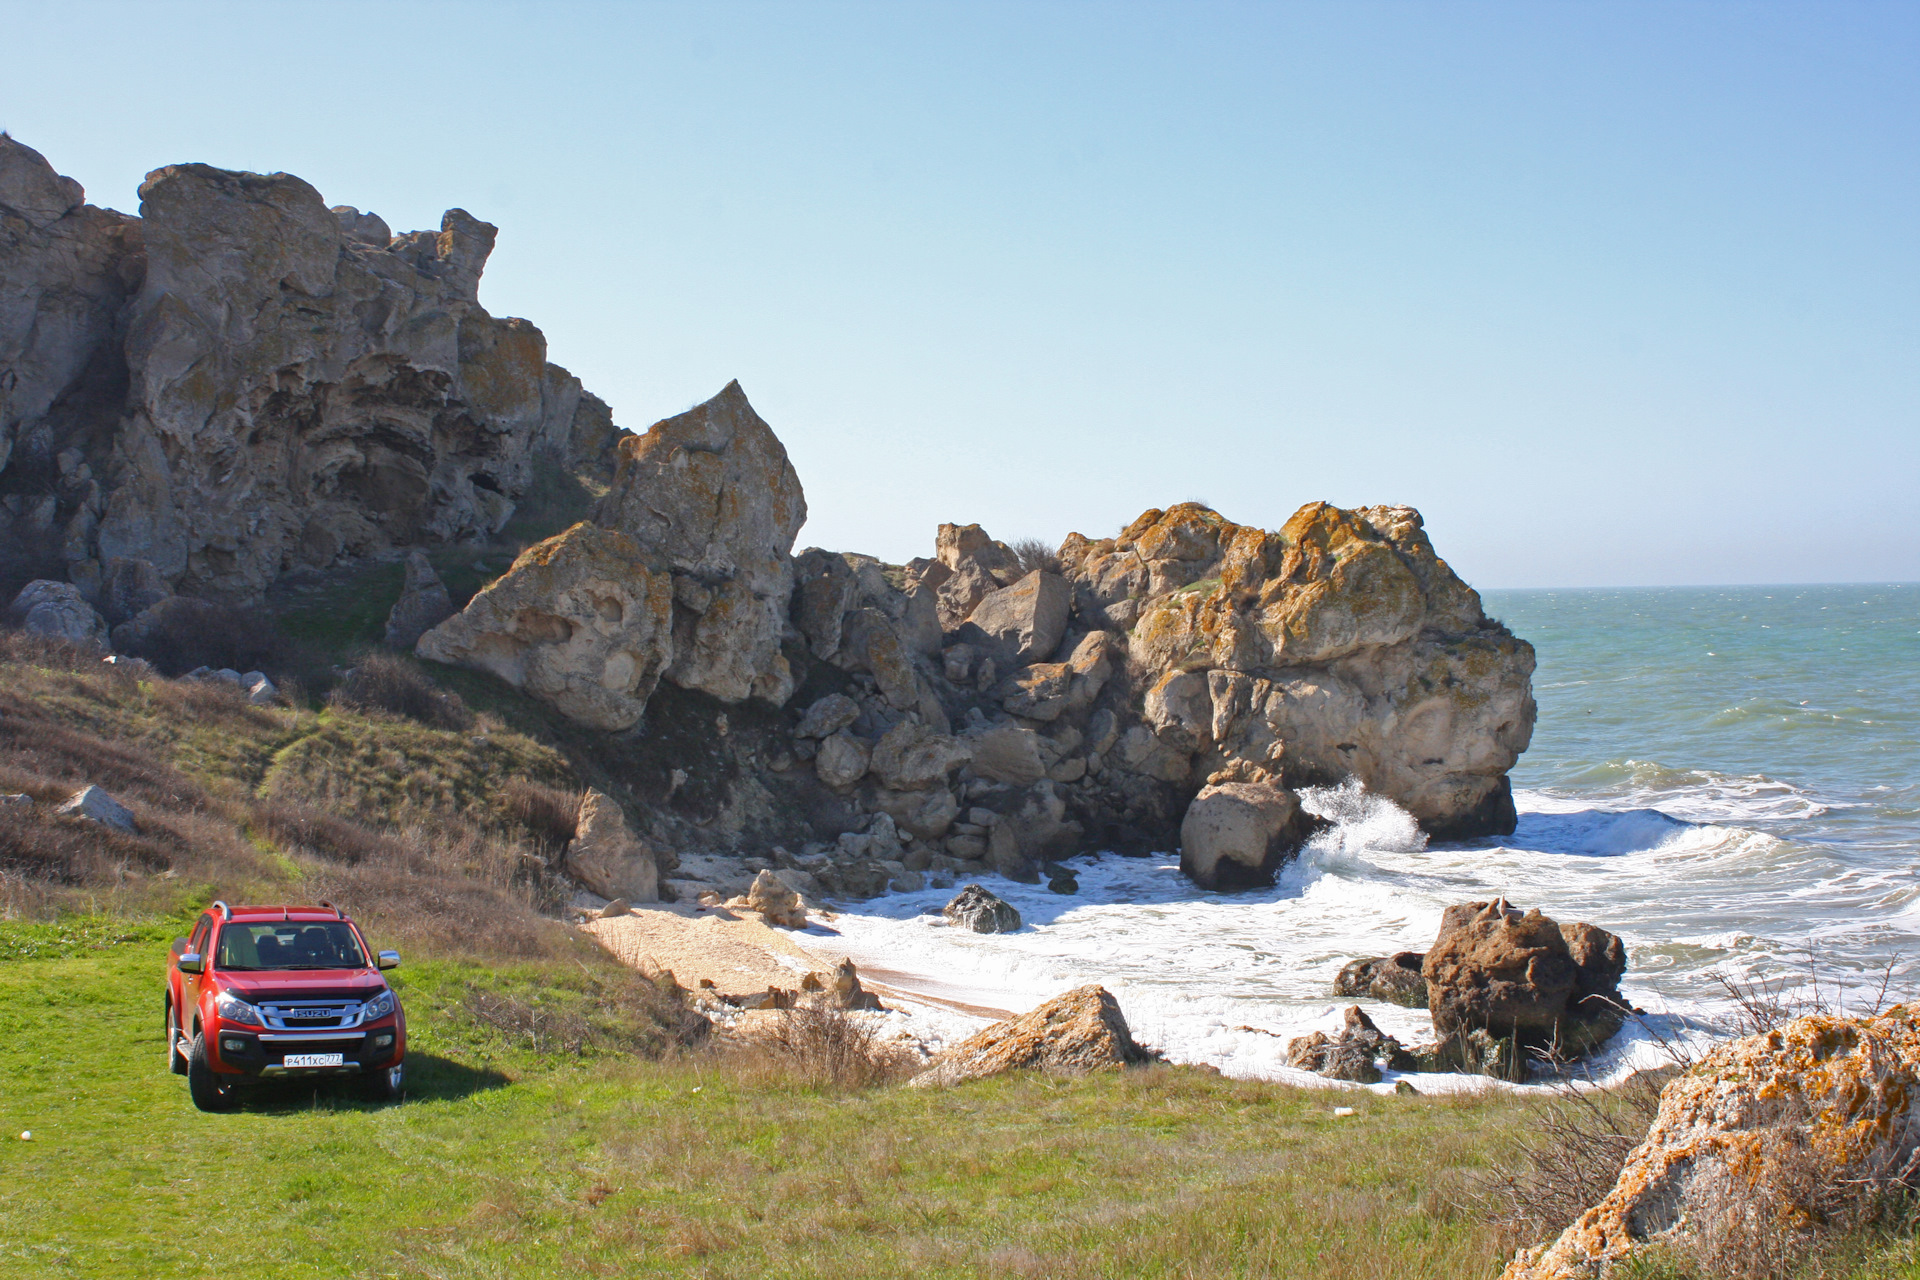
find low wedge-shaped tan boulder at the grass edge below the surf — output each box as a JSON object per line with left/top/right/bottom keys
{"left": 908, "top": 984, "right": 1154, "bottom": 1088}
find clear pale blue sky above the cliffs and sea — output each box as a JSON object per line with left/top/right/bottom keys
{"left": 0, "top": 0, "right": 1920, "bottom": 587}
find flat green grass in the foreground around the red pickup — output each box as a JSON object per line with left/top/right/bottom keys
{"left": 0, "top": 921, "right": 1543, "bottom": 1278}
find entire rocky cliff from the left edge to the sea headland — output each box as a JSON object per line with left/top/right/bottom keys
{"left": 0, "top": 136, "right": 1534, "bottom": 894}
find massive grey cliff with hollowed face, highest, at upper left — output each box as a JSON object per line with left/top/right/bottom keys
{"left": 0, "top": 138, "right": 611, "bottom": 599}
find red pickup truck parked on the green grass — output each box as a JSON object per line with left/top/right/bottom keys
{"left": 167, "top": 902, "right": 407, "bottom": 1111}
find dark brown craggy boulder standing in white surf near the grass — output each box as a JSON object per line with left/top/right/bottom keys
{"left": 1421, "top": 898, "right": 1626, "bottom": 1057}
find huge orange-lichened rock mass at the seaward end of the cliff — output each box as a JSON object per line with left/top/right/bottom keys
{"left": 1060, "top": 503, "right": 1534, "bottom": 837}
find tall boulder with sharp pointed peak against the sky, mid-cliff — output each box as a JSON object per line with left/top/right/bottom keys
{"left": 593, "top": 382, "right": 806, "bottom": 702}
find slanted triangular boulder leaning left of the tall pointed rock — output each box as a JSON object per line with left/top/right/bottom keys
{"left": 415, "top": 524, "right": 674, "bottom": 729}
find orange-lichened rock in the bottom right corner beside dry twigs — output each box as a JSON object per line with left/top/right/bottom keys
{"left": 1501, "top": 1006, "right": 1920, "bottom": 1280}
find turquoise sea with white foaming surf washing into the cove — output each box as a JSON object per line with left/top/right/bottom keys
{"left": 806, "top": 583, "right": 1920, "bottom": 1092}
